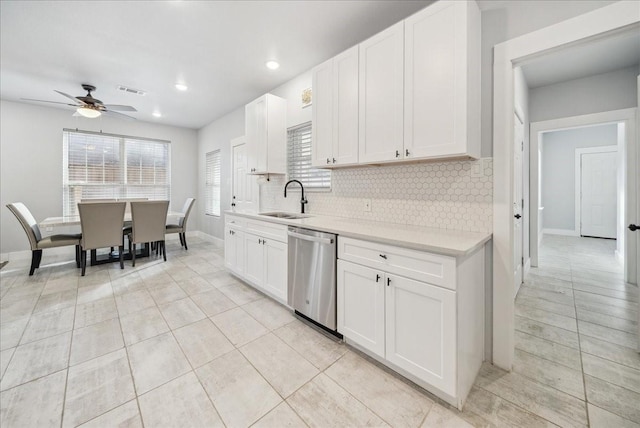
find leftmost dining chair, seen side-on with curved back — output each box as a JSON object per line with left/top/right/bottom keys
{"left": 7, "top": 202, "right": 81, "bottom": 276}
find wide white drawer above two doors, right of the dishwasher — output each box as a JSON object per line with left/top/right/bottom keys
{"left": 338, "top": 237, "right": 456, "bottom": 290}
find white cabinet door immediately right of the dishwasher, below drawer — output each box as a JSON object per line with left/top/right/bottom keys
{"left": 337, "top": 260, "right": 385, "bottom": 357}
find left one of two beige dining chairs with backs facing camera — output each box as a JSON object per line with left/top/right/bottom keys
{"left": 78, "top": 202, "right": 125, "bottom": 276}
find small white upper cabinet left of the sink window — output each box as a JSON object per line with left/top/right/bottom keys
{"left": 245, "top": 94, "right": 287, "bottom": 174}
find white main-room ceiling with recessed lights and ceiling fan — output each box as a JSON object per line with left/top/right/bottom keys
{"left": 0, "top": 0, "right": 432, "bottom": 129}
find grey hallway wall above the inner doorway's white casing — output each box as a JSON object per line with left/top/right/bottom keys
{"left": 530, "top": 66, "right": 638, "bottom": 122}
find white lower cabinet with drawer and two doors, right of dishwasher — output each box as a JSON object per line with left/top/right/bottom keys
{"left": 337, "top": 237, "right": 484, "bottom": 409}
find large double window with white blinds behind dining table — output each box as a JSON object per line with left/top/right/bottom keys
{"left": 62, "top": 129, "right": 171, "bottom": 216}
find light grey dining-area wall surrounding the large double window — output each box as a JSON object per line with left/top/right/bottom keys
{"left": 0, "top": 100, "right": 198, "bottom": 254}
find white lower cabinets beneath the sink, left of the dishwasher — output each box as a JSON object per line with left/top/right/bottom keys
{"left": 224, "top": 216, "right": 288, "bottom": 304}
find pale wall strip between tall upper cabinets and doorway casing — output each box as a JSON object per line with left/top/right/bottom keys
{"left": 479, "top": 0, "right": 615, "bottom": 157}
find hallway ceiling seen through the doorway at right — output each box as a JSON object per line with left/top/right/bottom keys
{"left": 522, "top": 26, "right": 640, "bottom": 89}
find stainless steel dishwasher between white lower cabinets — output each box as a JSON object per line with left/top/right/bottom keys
{"left": 288, "top": 226, "right": 337, "bottom": 335}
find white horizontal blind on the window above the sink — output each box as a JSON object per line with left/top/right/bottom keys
{"left": 287, "top": 122, "right": 331, "bottom": 190}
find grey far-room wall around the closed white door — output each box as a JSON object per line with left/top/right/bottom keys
{"left": 542, "top": 124, "right": 618, "bottom": 231}
